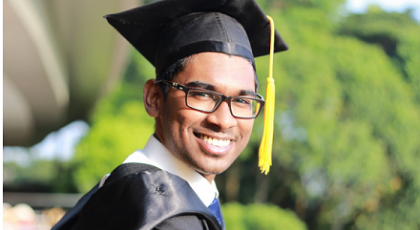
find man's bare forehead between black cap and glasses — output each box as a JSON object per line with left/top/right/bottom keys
{"left": 174, "top": 52, "right": 255, "bottom": 93}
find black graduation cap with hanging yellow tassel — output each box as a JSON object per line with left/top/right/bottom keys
{"left": 104, "top": 0, "right": 288, "bottom": 173}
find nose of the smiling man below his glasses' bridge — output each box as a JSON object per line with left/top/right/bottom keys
{"left": 207, "top": 101, "right": 238, "bottom": 130}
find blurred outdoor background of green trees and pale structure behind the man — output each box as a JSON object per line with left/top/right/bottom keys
{"left": 3, "top": 0, "right": 420, "bottom": 230}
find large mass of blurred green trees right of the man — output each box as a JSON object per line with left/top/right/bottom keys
{"left": 217, "top": 4, "right": 420, "bottom": 229}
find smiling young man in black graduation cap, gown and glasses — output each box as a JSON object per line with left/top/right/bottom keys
{"left": 53, "top": 0, "right": 287, "bottom": 229}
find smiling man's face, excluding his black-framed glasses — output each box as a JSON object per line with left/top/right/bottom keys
{"left": 156, "top": 52, "right": 255, "bottom": 180}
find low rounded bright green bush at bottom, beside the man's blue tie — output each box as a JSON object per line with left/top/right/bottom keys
{"left": 222, "top": 203, "right": 306, "bottom": 230}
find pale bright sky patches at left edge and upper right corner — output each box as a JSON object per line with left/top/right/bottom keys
{"left": 3, "top": 0, "right": 420, "bottom": 165}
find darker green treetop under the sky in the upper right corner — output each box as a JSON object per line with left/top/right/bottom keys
{"left": 338, "top": 8, "right": 420, "bottom": 104}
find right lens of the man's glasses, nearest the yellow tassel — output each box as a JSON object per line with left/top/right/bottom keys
{"left": 231, "top": 97, "right": 261, "bottom": 118}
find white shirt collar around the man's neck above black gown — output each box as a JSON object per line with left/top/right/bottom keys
{"left": 124, "top": 135, "right": 219, "bottom": 207}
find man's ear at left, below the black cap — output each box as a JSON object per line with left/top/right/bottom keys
{"left": 143, "top": 79, "right": 163, "bottom": 117}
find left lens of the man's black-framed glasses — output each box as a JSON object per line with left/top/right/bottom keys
{"left": 187, "top": 89, "right": 221, "bottom": 112}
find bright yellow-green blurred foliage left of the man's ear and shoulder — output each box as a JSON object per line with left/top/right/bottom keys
{"left": 73, "top": 52, "right": 154, "bottom": 192}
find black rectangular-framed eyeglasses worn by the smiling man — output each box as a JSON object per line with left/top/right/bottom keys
{"left": 156, "top": 80, "right": 264, "bottom": 118}
